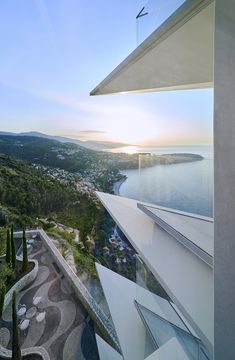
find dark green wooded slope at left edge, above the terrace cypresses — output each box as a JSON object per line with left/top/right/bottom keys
{"left": 0, "top": 155, "right": 81, "bottom": 227}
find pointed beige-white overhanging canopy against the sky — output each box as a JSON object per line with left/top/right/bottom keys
{"left": 91, "top": 0, "right": 214, "bottom": 95}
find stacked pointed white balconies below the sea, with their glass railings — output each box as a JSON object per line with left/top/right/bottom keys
{"left": 97, "top": 193, "right": 213, "bottom": 359}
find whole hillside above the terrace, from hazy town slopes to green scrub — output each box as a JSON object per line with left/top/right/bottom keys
{"left": 0, "top": 135, "right": 202, "bottom": 249}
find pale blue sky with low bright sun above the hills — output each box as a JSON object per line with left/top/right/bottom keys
{"left": 0, "top": 0, "right": 213, "bottom": 145}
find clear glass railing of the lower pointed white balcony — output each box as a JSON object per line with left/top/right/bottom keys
{"left": 135, "top": 256, "right": 212, "bottom": 360}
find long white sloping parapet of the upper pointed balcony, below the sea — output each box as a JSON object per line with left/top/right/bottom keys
{"left": 97, "top": 193, "right": 214, "bottom": 351}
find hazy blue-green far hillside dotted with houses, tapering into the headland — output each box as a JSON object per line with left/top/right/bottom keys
{"left": 0, "top": 135, "right": 203, "bottom": 172}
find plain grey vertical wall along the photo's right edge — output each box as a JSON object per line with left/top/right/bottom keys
{"left": 214, "top": 0, "right": 235, "bottom": 360}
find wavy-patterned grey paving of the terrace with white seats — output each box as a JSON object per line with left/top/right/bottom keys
{"left": 0, "top": 238, "right": 99, "bottom": 360}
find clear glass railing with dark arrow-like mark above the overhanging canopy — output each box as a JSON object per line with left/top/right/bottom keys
{"left": 136, "top": 0, "right": 185, "bottom": 45}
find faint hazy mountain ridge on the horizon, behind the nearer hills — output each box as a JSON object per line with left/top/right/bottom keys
{"left": 0, "top": 131, "right": 129, "bottom": 151}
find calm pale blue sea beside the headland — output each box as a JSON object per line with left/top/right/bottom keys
{"left": 119, "top": 145, "right": 213, "bottom": 217}
